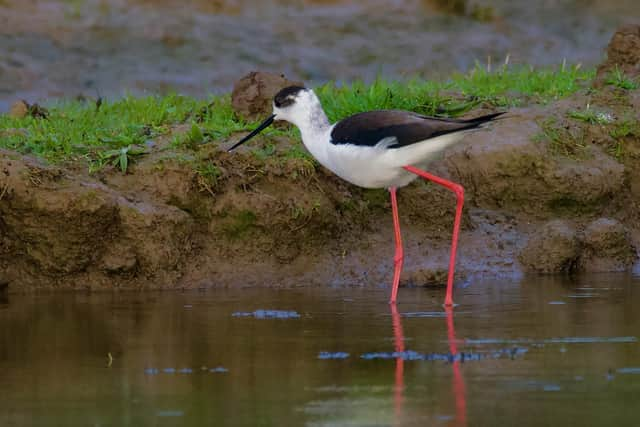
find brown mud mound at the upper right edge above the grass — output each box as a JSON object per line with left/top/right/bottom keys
{"left": 594, "top": 25, "right": 640, "bottom": 86}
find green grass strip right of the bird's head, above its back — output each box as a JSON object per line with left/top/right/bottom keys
{"left": 316, "top": 65, "right": 595, "bottom": 121}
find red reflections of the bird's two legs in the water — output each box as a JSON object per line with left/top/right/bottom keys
{"left": 390, "top": 304, "right": 467, "bottom": 427}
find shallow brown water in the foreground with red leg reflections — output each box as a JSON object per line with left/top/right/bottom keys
{"left": 0, "top": 275, "right": 640, "bottom": 426}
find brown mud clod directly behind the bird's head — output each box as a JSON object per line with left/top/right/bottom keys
{"left": 231, "top": 71, "right": 304, "bottom": 121}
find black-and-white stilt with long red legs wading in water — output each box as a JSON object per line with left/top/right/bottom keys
{"left": 227, "top": 86, "right": 505, "bottom": 307}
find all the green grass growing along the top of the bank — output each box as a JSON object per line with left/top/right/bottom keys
{"left": 0, "top": 66, "right": 594, "bottom": 171}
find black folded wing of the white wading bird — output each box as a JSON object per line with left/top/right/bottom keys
{"left": 331, "top": 110, "right": 504, "bottom": 148}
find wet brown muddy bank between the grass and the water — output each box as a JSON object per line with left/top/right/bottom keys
{"left": 0, "top": 30, "right": 640, "bottom": 290}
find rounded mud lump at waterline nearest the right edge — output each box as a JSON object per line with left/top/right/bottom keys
{"left": 579, "top": 218, "right": 637, "bottom": 272}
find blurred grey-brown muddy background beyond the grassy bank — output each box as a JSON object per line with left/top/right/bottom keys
{"left": 0, "top": 0, "right": 640, "bottom": 111}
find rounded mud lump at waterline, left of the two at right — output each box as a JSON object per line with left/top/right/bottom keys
{"left": 518, "top": 220, "right": 580, "bottom": 273}
